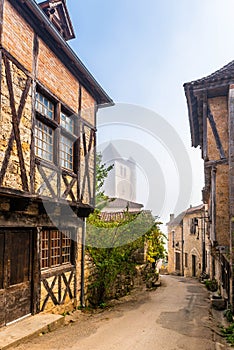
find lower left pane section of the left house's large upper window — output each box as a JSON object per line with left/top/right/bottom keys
{"left": 35, "top": 120, "right": 54, "bottom": 162}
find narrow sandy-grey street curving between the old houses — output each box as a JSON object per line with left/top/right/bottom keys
{"left": 9, "top": 276, "right": 221, "bottom": 350}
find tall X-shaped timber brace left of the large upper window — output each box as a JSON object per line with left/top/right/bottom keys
{"left": 0, "top": 54, "right": 32, "bottom": 192}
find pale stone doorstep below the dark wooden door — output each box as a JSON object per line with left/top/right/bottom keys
{"left": 0, "top": 314, "right": 64, "bottom": 350}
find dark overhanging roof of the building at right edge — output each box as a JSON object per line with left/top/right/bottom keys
{"left": 184, "top": 61, "right": 234, "bottom": 147}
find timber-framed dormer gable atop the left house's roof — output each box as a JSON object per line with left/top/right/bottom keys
{"left": 39, "top": 0, "right": 75, "bottom": 41}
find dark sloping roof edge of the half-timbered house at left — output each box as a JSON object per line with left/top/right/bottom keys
{"left": 9, "top": 0, "right": 114, "bottom": 107}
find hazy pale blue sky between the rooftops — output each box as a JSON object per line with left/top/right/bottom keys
{"left": 35, "top": 0, "right": 234, "bottom": 230}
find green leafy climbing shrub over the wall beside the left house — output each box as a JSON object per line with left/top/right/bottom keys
{"left": 86, "top": 154, "right": 165, "bottom": 305}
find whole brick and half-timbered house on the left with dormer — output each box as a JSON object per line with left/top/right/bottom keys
{"left": 0, "top": 0, "right": 112, "bottom": 326}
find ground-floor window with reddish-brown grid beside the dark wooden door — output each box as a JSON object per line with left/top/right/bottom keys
{"left": 41, "top": 230, "right": 72, "bottom": 269}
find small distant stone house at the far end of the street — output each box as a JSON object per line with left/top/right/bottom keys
{"left": 167, "top": 205, "right": 210, "bottom": 277}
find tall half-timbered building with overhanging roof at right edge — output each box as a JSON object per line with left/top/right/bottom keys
{"left": 184, "top": 61, "right": 234, "bottom": 306}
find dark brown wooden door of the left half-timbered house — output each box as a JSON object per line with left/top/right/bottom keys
{"left": 0, "top": 230, "right": 32, "bottom": 325}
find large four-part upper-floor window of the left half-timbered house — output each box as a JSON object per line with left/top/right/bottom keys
{"left": 35, "top": 86, "right": 79, "bottom": 174}
